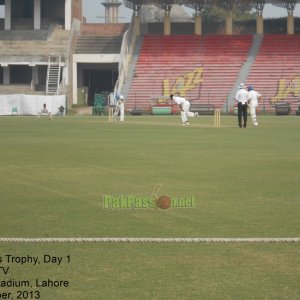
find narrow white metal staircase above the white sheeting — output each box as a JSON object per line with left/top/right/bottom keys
{"left": 46, "top": 56, "right": 61, "bottom": 95}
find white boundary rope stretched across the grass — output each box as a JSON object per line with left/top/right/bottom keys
{"left": 0, "top": 237, "right": 300, "bottom": 243}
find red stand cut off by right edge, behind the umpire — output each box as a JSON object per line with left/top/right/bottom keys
{"left": 247, "top": 34, "right": 300, "bottom": 111}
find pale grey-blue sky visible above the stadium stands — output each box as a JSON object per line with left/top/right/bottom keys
{"left": 82, "top": 0, "right": 300, "bottom": 23}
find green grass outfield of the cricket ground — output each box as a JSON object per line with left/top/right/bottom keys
{"left": 0, "top": 116, "right": 300, "bottom": 300}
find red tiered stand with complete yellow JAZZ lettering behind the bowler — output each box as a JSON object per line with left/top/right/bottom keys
{"left": 127, "top": 35, "right": 253, "bottom": 109}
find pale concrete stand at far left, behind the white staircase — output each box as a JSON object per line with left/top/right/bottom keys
{"left": 0, "top": 24, "right": 70, "bottom": 95}
